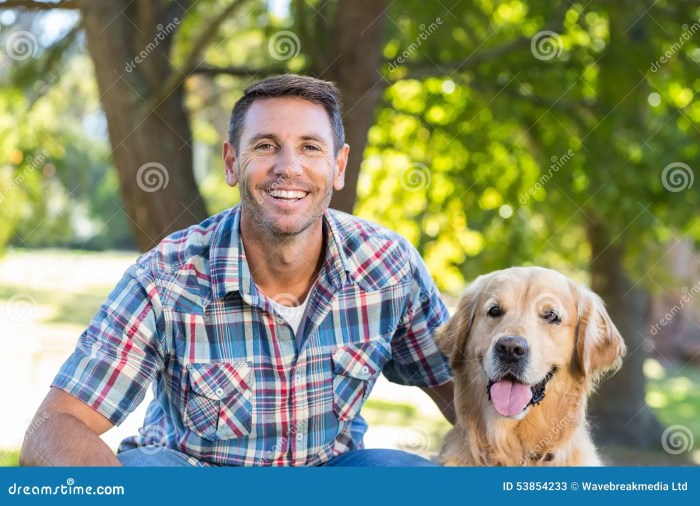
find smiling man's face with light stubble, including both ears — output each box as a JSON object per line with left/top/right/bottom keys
{"left": 224, "top": 97, "right": 349, "bottom": 238}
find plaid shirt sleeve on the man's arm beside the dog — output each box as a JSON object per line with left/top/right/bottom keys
{"left": 383, "top": 245, "right": 452, "bottom": 387}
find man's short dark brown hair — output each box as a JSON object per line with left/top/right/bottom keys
{"left": 228, "top": 74, "right": 345, "bottom": 153}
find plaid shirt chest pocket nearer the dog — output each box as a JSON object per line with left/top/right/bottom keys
{"left": 332, "top": 340, "right": 391, "bottom": 421}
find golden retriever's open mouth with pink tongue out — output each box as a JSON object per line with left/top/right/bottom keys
{"left": 487, "top": 367, "right": 557, "bottom": 416}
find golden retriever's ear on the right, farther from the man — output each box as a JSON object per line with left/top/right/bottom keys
{"left": 576, "top": 286, "right": 627, "bottom": 385}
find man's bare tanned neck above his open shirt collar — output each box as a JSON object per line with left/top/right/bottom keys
{"left": 241, "top": 213, "right": 325, "bottom": 306}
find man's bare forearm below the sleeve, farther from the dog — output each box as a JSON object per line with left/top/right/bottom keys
{"left": 19, "top": 388, "right": 121, "bottom": 466}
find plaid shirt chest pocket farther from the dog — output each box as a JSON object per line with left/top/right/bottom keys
{"left": 185, "top": 362, "right": 253, "bottom": 441}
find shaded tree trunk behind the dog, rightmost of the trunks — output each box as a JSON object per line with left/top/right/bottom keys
{"left": 587, "top": 221, "right": 662, "bottom": 448}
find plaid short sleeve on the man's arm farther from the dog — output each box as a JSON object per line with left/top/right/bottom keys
{"left": 51, "top": 264, "right": 164, "bottom": 425}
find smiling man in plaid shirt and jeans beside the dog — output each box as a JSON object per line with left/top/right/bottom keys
{"left": 20, "top": 75, "right": 454, "bottom": 466}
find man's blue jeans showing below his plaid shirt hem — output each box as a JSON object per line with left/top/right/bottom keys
{"left": 117, "top": 447, "right": 437, "bottom": 467}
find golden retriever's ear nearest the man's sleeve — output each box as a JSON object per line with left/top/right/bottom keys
{"left": 436, "top": 276, "right": 483, "bottom": 370}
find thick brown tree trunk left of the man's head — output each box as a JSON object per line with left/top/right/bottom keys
{"left": 80, "top": 0, "right": 207, "bottom": 250}
